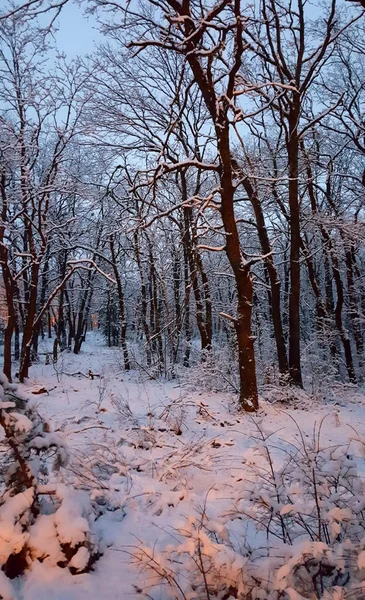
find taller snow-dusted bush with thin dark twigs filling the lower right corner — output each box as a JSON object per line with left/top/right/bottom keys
{"left": 232, "top": 419, "right": 365, "bottom": 600}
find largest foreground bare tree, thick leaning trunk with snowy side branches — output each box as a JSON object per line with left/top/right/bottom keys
{"left": 91, "top": 0, "right": 258, "bottom": 410}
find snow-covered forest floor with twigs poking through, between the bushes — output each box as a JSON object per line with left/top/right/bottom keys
{"left": 5, "top": 334, "right": 365, "bottom": 600}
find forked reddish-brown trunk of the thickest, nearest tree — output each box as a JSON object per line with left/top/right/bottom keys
{"left": 129, "top": 0, "right": 258, "bottom": 411}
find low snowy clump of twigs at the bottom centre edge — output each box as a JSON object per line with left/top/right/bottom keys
{"left": 127, "top": 507, "right": 258, "bottom": 600}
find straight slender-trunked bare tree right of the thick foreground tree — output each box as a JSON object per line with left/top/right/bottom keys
{"left": 242, "top": 0, "right": 359, "bottom": 386}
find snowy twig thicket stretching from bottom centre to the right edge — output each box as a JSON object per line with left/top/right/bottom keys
{"left": 128, "top": 420, "right": 365, "bottom": 600}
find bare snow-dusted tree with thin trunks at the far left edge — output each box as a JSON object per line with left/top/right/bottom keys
{"left": 0, "top": 15, "right": 87, "bottom": 380}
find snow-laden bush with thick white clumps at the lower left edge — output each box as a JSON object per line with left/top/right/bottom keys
{"left": 0, "top": 376, "right": 98, "bottom": 588}
